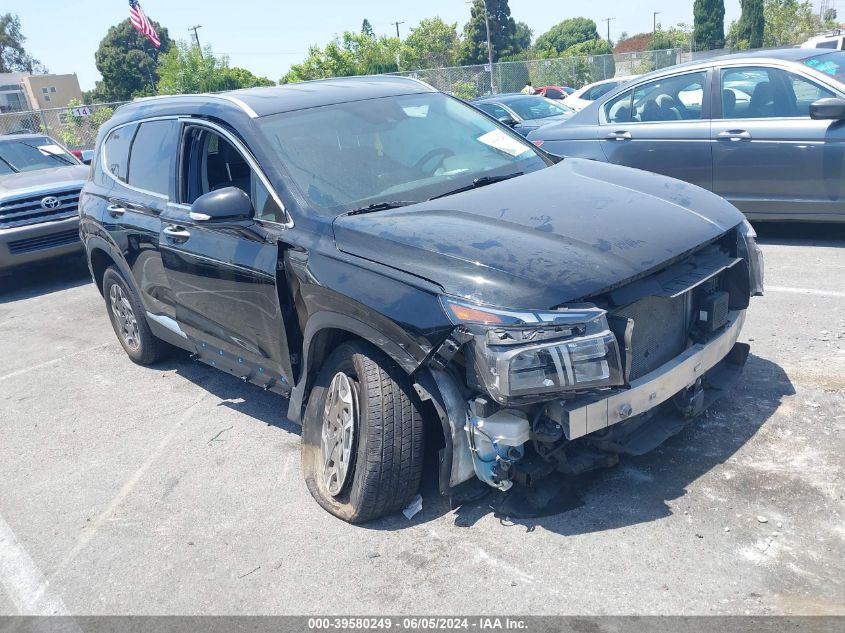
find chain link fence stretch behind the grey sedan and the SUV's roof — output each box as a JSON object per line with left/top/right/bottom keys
{"left": 393, "top": 48, "right": 784, "bottom": 99}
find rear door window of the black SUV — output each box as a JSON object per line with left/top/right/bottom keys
{"left": 129, "top": 120, "right": 179, "bottom": 196}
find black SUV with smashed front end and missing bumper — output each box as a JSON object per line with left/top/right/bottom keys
{"left": 81, "top": 77, "right": 762, "bottom": 522}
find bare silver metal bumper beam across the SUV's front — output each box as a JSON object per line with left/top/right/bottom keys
{"left": 546, "top": 311, "right": 747, "bottom": 440}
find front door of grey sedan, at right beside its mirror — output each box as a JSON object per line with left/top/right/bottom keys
{"left": 712, "top": 66, "right": 845, "bottom": 219}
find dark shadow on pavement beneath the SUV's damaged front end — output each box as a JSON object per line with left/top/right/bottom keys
{"left": 363, "top": 356, "right": 795, "bottom": 535}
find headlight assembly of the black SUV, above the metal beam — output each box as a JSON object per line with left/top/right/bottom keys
{"left": 443, "top": 298, "right": 623, "bottom": 404}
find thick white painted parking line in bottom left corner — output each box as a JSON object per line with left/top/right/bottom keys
{"left": 0, "top": 516, "right": 70, "bottom": 615}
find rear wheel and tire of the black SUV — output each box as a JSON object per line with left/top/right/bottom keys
{"left": 103, "top": 266, "right": 172, "bottom": 365}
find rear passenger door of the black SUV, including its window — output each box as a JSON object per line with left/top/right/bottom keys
{"left": 103, "top": 119, "right": 179, "bottom": 319}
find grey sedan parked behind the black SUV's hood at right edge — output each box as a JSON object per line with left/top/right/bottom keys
{"left": 531, "top": 49, "right": 845, "bottom": 222}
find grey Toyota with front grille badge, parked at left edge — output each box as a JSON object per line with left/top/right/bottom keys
{"left": 0, "top": 134, "right": 88, "bottom": 270}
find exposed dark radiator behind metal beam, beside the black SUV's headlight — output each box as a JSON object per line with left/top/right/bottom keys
{"left": 614, "top": 293, "right": 690, "bottom": 380}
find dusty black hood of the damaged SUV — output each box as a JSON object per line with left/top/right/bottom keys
{"left": 334, "top": 159, "right": 742, "bottom": 309}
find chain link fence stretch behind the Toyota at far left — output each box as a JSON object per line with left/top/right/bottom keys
{"left": 0, "top": 102, "right": 123, "bottom": 150}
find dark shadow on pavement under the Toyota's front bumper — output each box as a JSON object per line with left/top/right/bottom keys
{"left": 0, "top": 253, "right": 92, "bottom": 303}
